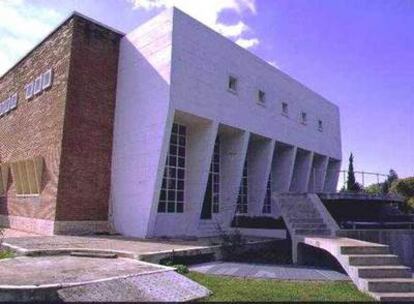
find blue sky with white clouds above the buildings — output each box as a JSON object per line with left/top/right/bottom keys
{"left": 0, "top": 0, "right": 414, "bottom": 177}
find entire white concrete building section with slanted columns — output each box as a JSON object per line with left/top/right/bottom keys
{"left": 111, "top": 9, "right": 342, "bottom": 237}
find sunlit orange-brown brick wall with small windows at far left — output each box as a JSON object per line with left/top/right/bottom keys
{"left": 0, "top": 20, "right": 73, "bottom": 223}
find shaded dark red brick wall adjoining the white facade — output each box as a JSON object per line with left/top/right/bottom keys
{"left": 56, "top": 18, "right": 121, "bottom": 221}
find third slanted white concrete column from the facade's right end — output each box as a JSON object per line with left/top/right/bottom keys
{"left": 290, "top": 149, "right": 313, "bottom": 192}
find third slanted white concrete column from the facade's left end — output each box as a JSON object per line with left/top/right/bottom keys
{"left": 247, "top": 136, "right": 275, "bottom": 215}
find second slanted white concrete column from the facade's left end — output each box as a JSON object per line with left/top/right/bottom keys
{"left": 217, "top": 129, "right": 250, "bottom": 227}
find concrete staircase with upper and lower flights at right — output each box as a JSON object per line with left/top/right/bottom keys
{"left": 273, "top": 193, "right": 414, "bottom": 301}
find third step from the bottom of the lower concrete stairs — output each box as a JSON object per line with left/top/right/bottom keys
{"left": 358, "top": 265, "right": 412, "bottom": 279}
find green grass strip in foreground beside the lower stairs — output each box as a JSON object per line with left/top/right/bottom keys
{"left": 187, "top": 272, "right": 374, "bottom": 302}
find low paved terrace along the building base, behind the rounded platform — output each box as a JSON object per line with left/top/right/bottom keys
{"left": 3, "top": 236, "right": 275, "bottom": 263}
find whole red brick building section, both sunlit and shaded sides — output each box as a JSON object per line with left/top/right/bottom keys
{"left": 0, "top": 14, "right": 122, "bottom": 234}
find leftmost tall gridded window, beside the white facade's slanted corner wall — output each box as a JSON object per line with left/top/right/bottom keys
{"left": 158, "top": 123, "right": 187, "bottom": 213}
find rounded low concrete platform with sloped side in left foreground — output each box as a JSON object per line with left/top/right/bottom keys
{"left": 0, "top": 256, "right": 210, "bottom": 302}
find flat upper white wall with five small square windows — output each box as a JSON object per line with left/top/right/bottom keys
{"left": 171, "top": 10, "right": 341, "bottom": 159}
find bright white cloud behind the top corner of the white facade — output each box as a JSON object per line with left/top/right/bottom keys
{"left": 128, "top": 0, "right": 259, "bottom": 48}
